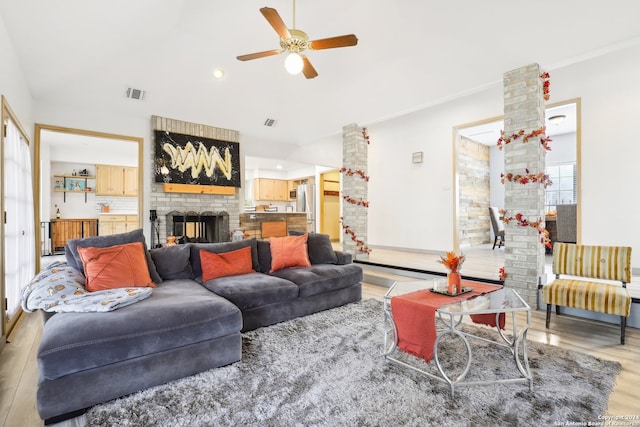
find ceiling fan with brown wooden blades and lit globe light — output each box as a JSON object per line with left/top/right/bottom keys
{"left": 237, "top": 0, "right": 358, "bottom": 79}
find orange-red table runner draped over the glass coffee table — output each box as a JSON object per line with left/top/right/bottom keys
{"left": 391, "top": 280, "right": 505, "bottom": 362}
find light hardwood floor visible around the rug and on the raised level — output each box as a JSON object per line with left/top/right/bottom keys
{"left": 0, "top": 250, "right": 640, "bottom": 427}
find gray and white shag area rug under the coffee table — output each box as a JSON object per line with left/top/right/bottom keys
{"left": 86, "top": 300, "right": 620, "bottom": 427}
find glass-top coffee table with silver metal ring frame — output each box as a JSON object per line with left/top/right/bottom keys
{"left": 383, "top": 279, "right": 533, "bottom": 396}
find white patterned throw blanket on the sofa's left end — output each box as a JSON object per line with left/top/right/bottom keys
{"left": 22, "top": 262, "right": 152, "bottom": 313}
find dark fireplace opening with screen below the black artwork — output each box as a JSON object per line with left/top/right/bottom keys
{"left": 167, "top": 211, "right": 229, "bottom": 243}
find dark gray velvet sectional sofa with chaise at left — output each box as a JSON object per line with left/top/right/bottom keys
{"left": 37, "top": 230, "right": 362, "bottom": 423}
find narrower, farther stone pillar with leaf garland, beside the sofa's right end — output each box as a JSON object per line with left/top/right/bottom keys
{"left": 342, "top": 124, "right": 369, "bottom": 258}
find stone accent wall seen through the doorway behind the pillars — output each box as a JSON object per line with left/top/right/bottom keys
{"left": 456, "top": 137, "right": 491, "bottom": 249}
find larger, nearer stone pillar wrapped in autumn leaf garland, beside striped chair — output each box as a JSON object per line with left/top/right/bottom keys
{"left": 503, "top": 64, "right": 546, "bottom": 307}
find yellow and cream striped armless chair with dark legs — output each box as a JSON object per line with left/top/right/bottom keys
{"left": 542, "top": 243, "right": 631, "bottom": 344}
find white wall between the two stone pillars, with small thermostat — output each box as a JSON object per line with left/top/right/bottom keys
{"left": 367, "top": 86, "right": 502, "bottom": 251}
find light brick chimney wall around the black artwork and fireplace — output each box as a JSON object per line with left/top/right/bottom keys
{"left": 149, "top": 116, "right": 240, "bottom": 245}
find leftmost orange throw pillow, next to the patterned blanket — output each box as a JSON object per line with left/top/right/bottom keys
{"left": 78, "top": 242, "right": 156, "bottom": 292}
